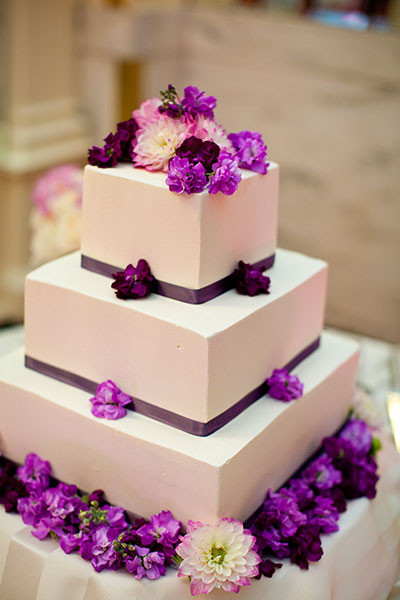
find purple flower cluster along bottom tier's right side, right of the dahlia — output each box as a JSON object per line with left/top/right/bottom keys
{"left": 251, "top": 419, "right": 378, "bottom": 577}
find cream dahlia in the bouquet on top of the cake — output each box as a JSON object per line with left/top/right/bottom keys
{"left": 135, "top": 116, "right": 188, "bottom": 171}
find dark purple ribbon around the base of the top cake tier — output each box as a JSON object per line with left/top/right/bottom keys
{"left": 81, "top": 254, "right": 275, "bottom": 304}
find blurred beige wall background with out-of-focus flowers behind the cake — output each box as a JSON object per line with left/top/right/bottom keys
{"left": 0, "top": 0, "right": 400, "bottom": 343}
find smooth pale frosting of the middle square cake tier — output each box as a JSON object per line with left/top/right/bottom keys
{"left": 25, "top": 250, "right": 327, "bottom": 423}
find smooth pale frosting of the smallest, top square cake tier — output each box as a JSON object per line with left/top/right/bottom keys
{"left": 82, "top": 163, "right": 279, "bottom": 289}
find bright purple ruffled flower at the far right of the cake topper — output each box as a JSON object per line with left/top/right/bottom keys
{"left": 228, "top": 131, "right": 269, "bottom": 175}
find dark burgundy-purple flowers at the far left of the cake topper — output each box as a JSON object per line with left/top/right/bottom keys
{"left": 88, "top": 118, "right": 138, "bottom": 169}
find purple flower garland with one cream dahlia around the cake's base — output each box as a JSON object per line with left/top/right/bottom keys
{"left": 0, "top": 417, "right": 380, "bottom": 595}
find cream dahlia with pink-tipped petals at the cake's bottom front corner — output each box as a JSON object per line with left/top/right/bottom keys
{"left": 176, "top": 519, "right": 261, "bottom": 596}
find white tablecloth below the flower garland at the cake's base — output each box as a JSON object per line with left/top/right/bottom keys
{"left": 0, "top": 442, "right": 400, "bottom": 600}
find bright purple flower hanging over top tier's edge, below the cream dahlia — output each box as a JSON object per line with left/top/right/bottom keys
{"left": 165, "top": 156, "right": 207, "bottom": 194}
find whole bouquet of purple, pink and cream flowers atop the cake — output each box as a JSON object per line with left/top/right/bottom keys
{"left": 88, "top": 84, "right": 269, "bottom": 195}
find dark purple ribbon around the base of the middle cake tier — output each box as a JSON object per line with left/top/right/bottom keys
{"left": 25, "top": 338, "right": 320, "bottom": 437}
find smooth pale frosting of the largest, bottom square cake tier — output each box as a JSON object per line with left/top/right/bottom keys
{"left": 0, "top": 333, "right": 358, "bottom": 522}
